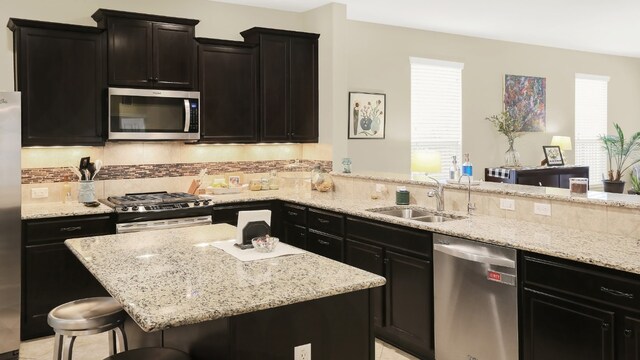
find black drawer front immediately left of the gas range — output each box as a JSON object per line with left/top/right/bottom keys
{"left": 24, "top": 215, "right": 116, "bottom": 245}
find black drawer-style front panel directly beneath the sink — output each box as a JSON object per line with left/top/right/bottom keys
{"left": 346, "top": 217, "right": 433, "bottom": 258}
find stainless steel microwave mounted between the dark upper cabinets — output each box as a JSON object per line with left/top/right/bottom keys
{"left": 108, "top": 88, "right": 200, "bottom": 141}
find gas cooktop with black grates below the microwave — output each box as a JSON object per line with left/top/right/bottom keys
{"left": 100, "top": 191, "right": 213, "bottom": 223}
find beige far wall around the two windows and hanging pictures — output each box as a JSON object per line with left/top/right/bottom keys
{"left": 345, "top": 21, "right": 640, "bottom": 174}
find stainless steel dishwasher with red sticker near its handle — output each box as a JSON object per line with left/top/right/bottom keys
{"left": 433, "top": 234, "right": 518, "bottom": 360}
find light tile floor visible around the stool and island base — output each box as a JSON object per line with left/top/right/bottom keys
{"left": 20, "top": 333, "right": 418, "bottom": 360}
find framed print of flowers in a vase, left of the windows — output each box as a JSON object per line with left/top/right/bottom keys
{"left": 348, "top": 92, "right": 386, "bottom": 139}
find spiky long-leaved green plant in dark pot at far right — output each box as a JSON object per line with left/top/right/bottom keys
{"left": 600, "top": 124, "right": 640, "bottom": 194}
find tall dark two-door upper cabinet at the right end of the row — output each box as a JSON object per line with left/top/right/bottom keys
{"left": 241, "top": 28, "right": 320, "bottom": 142}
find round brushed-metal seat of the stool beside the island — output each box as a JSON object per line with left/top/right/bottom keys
{"left": 47, "top": 297, "right": 125, "bottom": 331}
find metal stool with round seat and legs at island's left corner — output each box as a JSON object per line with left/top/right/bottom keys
{"left": 47, "top": 297, "right": 127, "bottom": 360}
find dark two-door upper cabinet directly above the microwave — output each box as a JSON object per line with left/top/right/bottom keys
{"left": 93, "top": 9, "right": 199, "bottom": 90}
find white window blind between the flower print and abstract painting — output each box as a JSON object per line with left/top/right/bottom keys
{"left": 410, "top": 57, "right": 464, "bottom": 178}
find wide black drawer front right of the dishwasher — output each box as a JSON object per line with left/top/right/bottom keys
{"left": 523, "top": 255, "right": 640, "bottom": 309}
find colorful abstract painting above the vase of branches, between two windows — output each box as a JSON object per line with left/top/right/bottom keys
{"left": 504, "top": 75, "right": 547, "bottom": 132}
